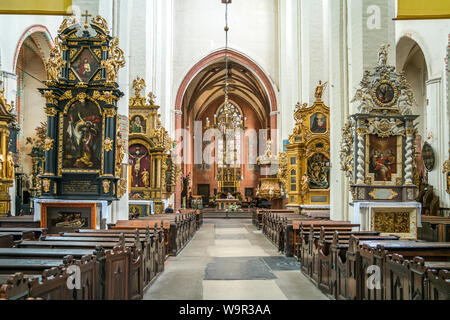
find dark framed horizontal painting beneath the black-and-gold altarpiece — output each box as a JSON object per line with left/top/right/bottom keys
{"left": 41, "top": 203, "right": 96, "bottom": 234}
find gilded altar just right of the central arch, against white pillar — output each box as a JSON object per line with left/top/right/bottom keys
{"left": 278, "top": 81, "right": 330, "bottom": 206}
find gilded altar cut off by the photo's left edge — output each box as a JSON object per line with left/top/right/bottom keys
{"left": 0, "top": 90, "right": 15, "bottom": 216}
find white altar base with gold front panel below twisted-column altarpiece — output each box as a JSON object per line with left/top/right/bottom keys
{"left": 352, "top": 201, "right": 422, "bottom": 239}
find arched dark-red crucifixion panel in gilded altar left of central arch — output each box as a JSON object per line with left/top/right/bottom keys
{"left": 129, "top": 144, "right": 151, "bottom": 188}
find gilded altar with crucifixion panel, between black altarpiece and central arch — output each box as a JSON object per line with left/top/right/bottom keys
{"left": 128, "top": 78, "right": 181, "bottom": 213}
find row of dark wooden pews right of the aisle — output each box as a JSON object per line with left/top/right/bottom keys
{"left": 253, "top": 210, "right": 450, "bottom": 300}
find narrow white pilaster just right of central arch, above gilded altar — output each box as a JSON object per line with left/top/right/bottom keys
{"left": 278, "top": 0, "right": 301, "bottom": 142}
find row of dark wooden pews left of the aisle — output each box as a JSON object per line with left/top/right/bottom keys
{"left": 0, "top": 210, "right": 202, "bottom": 300}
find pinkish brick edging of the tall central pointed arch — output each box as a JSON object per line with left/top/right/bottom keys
{"left": 175, "top": 49, "right": 278, "bottom": 129}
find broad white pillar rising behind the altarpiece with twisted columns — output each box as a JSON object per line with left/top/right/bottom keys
{"left": 328, "top": 0, "right": 395, "bottom": 221}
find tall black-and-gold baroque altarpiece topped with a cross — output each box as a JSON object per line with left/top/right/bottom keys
{"left": 34, "top": 14, "right": 125, "bottom": 227}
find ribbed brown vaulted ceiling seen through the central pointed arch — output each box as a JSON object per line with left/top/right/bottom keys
{"left": 183, "top": 61, "right": 270, "bottom": 125}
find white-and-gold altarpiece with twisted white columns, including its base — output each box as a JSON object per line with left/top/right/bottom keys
{"left": 341, "top": 45, "right": 420, "bottom": 238}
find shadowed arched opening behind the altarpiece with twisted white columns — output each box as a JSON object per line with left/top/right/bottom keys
{"left": 396, "top": 37, "right": 428, "bottom": 184}
